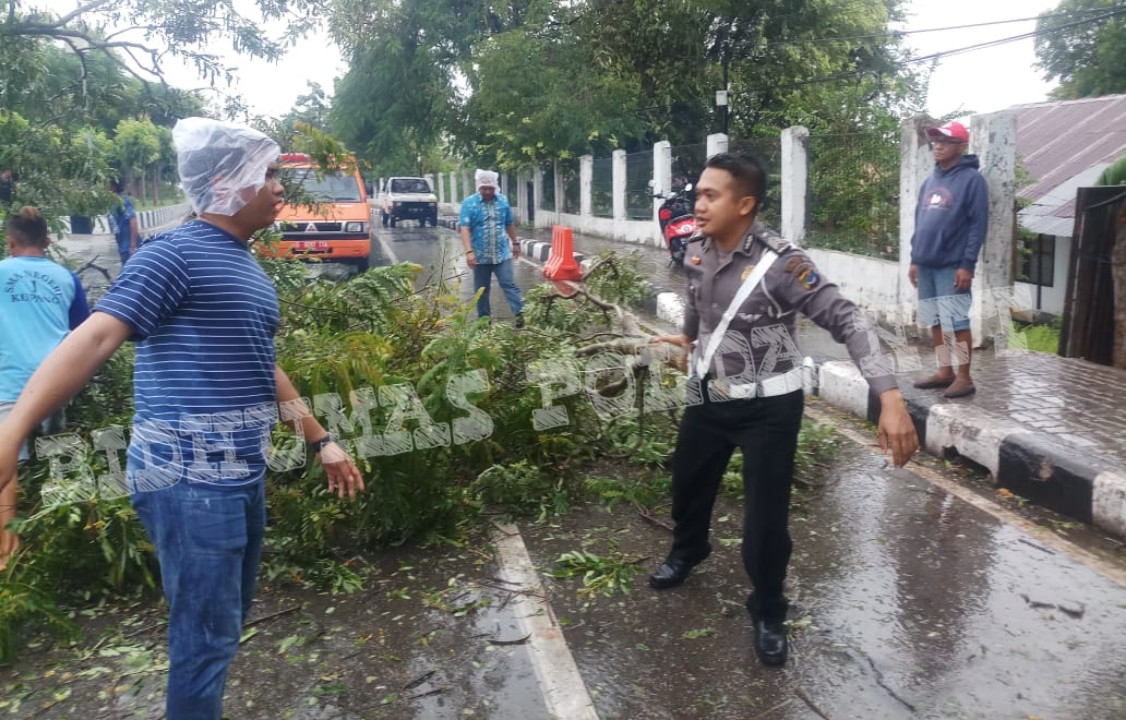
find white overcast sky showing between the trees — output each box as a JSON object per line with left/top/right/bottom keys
{"left": 37, "top": 0, "right": 1058, "bottom": 117}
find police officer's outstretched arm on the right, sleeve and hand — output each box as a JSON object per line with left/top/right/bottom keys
{"left": 770, "top": 250, "right": 919, "bottom": 468}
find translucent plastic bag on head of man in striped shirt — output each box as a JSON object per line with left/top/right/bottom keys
{"left": 172, "top": 117, "right": 280, "bottom": 215}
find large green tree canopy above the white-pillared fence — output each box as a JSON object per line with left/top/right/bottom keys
{"left": 329, "top": 0, "right": 926, "bottom": 171}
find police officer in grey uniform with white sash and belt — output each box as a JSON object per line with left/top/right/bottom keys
{"left": 649, "top": 153, "right": 919, "bottom": 665}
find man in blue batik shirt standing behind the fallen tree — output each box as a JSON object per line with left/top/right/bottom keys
{"left": 457, "top": 170, "right": 524, "bottom": 328}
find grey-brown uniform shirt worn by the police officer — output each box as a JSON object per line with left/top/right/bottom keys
{"left": 681, "top": 222, "right": 896, "bottom": 393}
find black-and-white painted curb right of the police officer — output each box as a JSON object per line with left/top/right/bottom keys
{"left": 819, "top": 361, "right": 1126, "bottom": 540}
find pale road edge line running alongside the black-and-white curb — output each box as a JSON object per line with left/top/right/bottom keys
{"left": 805, "top": 408, "right": 1126, "bottom": 587}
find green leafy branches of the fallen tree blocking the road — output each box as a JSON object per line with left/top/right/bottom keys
{"left": 0, "top": 250, "right": 671, "bottom": 661}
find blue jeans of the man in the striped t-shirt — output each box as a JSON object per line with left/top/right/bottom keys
{"left": 132, "top": 480, "right": 266, "bottom": 720}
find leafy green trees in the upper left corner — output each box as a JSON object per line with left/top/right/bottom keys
{"left": 0, "top": 0, "right": 313, "bottom": 224}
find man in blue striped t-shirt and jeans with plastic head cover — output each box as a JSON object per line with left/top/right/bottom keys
{"left": 0, "top": 117, "right": 364, "bottom": 720}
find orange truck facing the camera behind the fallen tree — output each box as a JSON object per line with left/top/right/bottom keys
{"left": 274, "top": 153, "right": 372, "bottom": 273}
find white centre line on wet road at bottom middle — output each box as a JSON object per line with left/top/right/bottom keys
{"left": 492, "top": 523, "right": 598, "bottom": 720}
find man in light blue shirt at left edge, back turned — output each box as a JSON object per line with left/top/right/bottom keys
{"left": 0, "top": 207, "right": 89, "bottom": 569}
